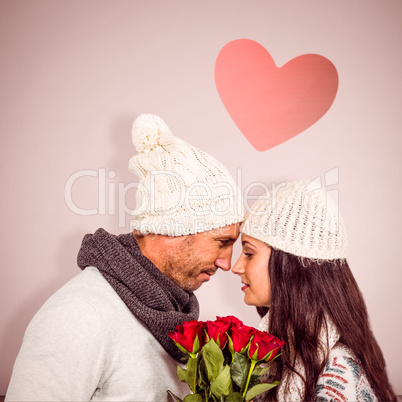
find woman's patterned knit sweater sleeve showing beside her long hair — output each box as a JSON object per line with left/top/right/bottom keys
{"left": 316, "top": 347, "right": 378, "bottom": 402}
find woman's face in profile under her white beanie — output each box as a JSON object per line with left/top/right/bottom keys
{"left": 232, "top": 235, "right": 271, "bottom": 307}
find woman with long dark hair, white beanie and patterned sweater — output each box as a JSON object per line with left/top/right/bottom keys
{"left": 232, "top": 181, "right": 396, "bottom": 401}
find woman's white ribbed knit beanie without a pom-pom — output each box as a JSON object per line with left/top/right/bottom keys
{"left": 240, "top": 180, "right": 347, "bottom": 260}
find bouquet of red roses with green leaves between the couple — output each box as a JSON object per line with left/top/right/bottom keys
{"left": 168, "top": 316, "right": 285, "bottom": 402}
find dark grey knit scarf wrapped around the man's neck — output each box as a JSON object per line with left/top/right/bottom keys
{"left": 77, "top": 229, "right": 199, "bottom": 361}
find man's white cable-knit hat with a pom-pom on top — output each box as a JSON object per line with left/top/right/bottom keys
{"left": 129, "top": 114, "right": 244, "bottom": 236}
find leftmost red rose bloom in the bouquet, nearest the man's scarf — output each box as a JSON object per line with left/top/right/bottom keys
{"left": 169, "top": 320, "right": 205, "bottom": 353}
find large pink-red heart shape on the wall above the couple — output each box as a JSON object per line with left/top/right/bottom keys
{"left": 215, "top": 39, "right": 338, "bottom": 151}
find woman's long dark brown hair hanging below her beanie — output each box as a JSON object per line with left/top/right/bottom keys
{"left": 257, "top": 249, "right": 396, "bottom": 401}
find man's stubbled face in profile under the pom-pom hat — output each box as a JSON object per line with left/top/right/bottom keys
{"left": 159, "top": 223, "right": 239, "bottom": 291}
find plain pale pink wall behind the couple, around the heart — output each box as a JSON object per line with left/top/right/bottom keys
{"left": 0, "top": 0, "right": 402, "bottom": 394}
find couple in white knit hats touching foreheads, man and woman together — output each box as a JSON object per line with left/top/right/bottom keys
{"left": 6, "top": 115, "right": 396, "bottom": 401}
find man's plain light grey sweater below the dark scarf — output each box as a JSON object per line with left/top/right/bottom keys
{"left": 6, "top": 267, "right": 190, "bottom": 401}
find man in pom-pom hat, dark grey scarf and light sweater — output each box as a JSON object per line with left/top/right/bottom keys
{"left": 6, "top": 115, "right": 243, "bottom": 401}
